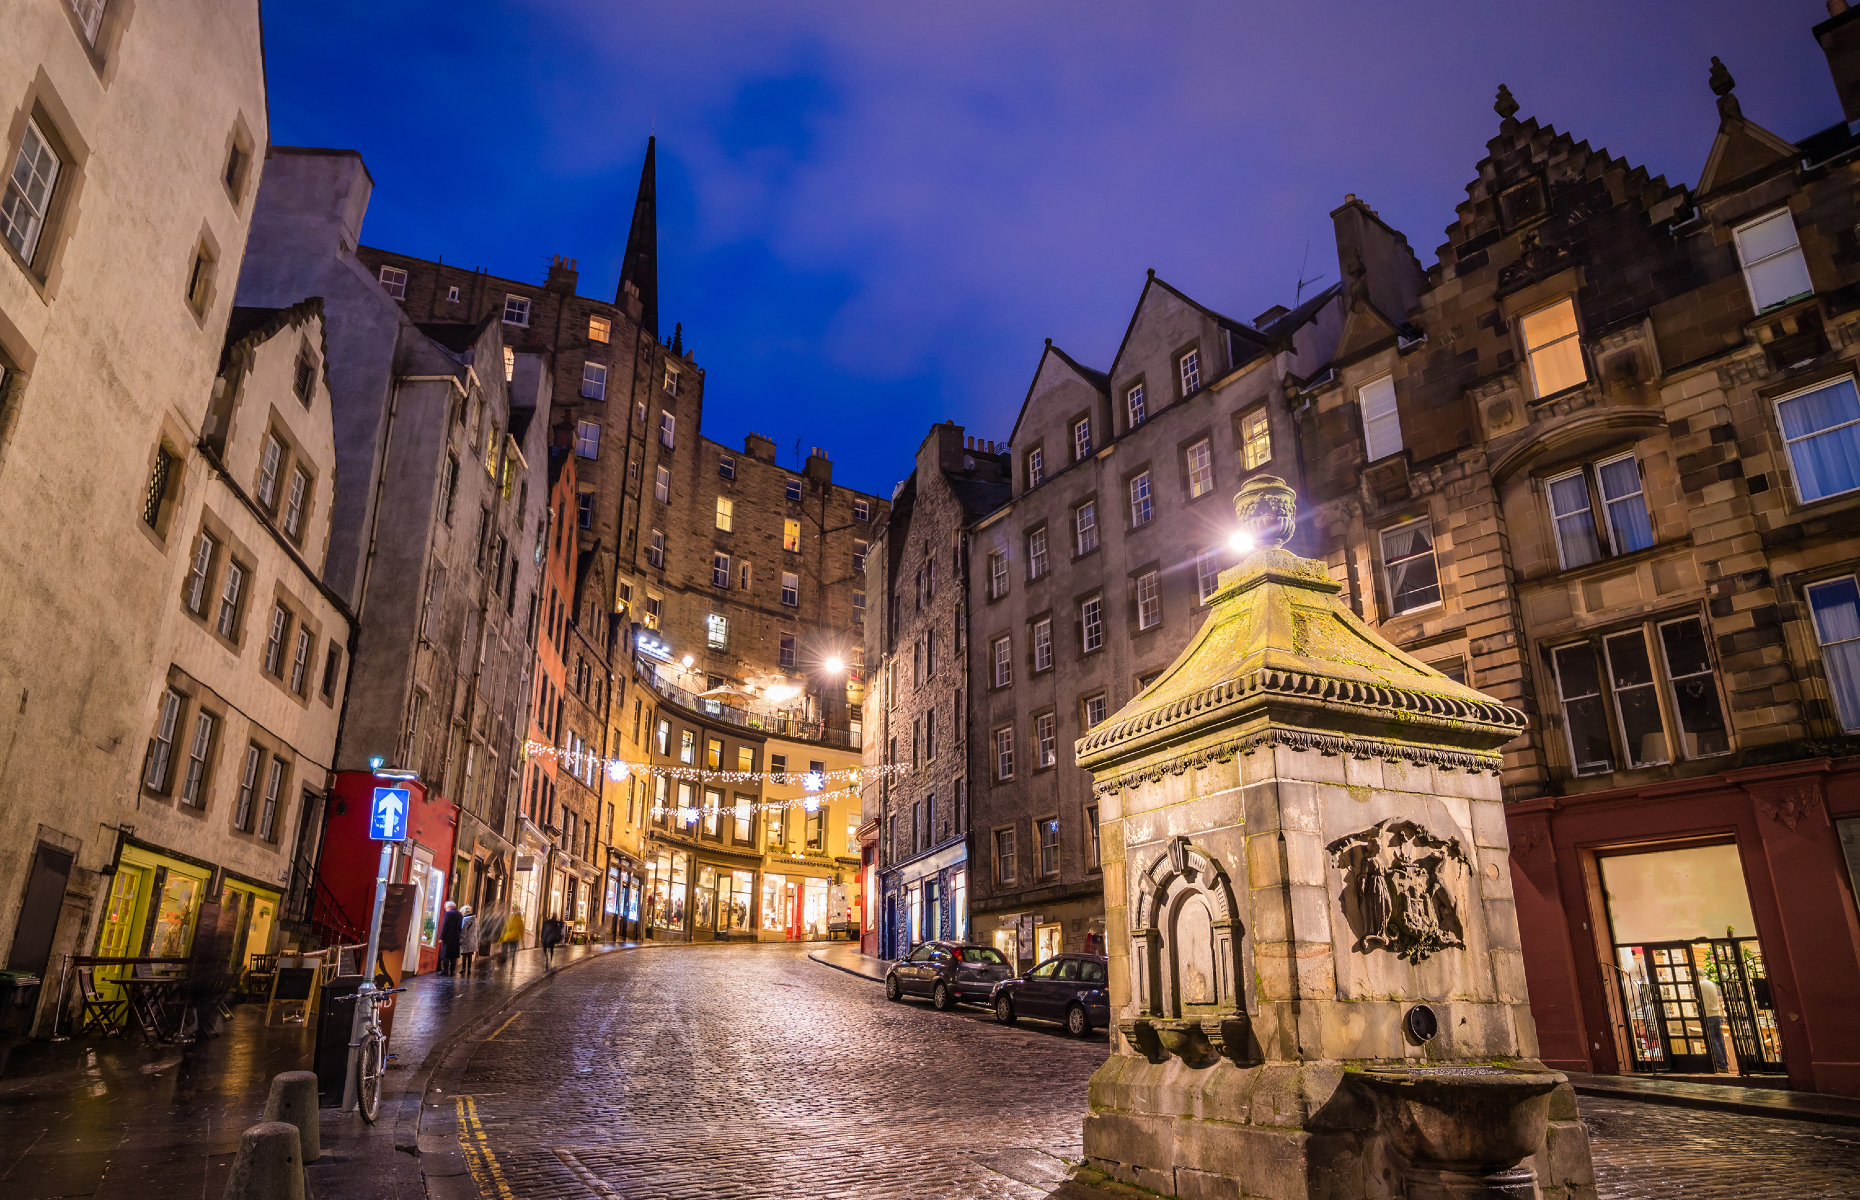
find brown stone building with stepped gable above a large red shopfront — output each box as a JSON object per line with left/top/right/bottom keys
{"left": 1295, "top": 16, "right": 1860, "bottom": 1094}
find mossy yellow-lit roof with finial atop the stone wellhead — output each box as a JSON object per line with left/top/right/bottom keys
{"left": 1077, "top": 476, "right": 1527, "bottom": 793}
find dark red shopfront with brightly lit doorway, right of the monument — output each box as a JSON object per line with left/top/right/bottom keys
{"left": 1507, "top": 759, "right": 1860, "bottom": 1096}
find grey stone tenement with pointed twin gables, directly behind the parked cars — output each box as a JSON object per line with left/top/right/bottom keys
{"left": 963, "top": 275, "right": 1354, "bottom": 964}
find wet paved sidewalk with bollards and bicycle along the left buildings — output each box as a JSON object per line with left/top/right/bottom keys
{"left": 0, "top": 943, "right": 631, "bottom": 1200}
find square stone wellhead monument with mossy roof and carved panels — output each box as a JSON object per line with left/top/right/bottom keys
{"left": 1077, "top": 476, "right": 1594, "bottom": 1200}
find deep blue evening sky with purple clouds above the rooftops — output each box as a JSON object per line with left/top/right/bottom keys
{"left": 264, "top": 0, "right": 1840, "bottom": 495}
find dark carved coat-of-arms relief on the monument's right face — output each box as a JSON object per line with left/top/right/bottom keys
{"left": 1324, "top": 817, "right": 1471, "bottom": 962}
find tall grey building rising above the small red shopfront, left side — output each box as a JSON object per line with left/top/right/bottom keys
{"left": 238, "top": 147, "right": 552, "bottom": 969}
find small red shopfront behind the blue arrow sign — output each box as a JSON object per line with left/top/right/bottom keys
{"left": 318, "top": 770, "right": 459, "bottom": 975}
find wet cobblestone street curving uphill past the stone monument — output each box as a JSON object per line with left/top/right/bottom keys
{"left": 428, "top": 945, "right": 1860, "bottom": 1200}
